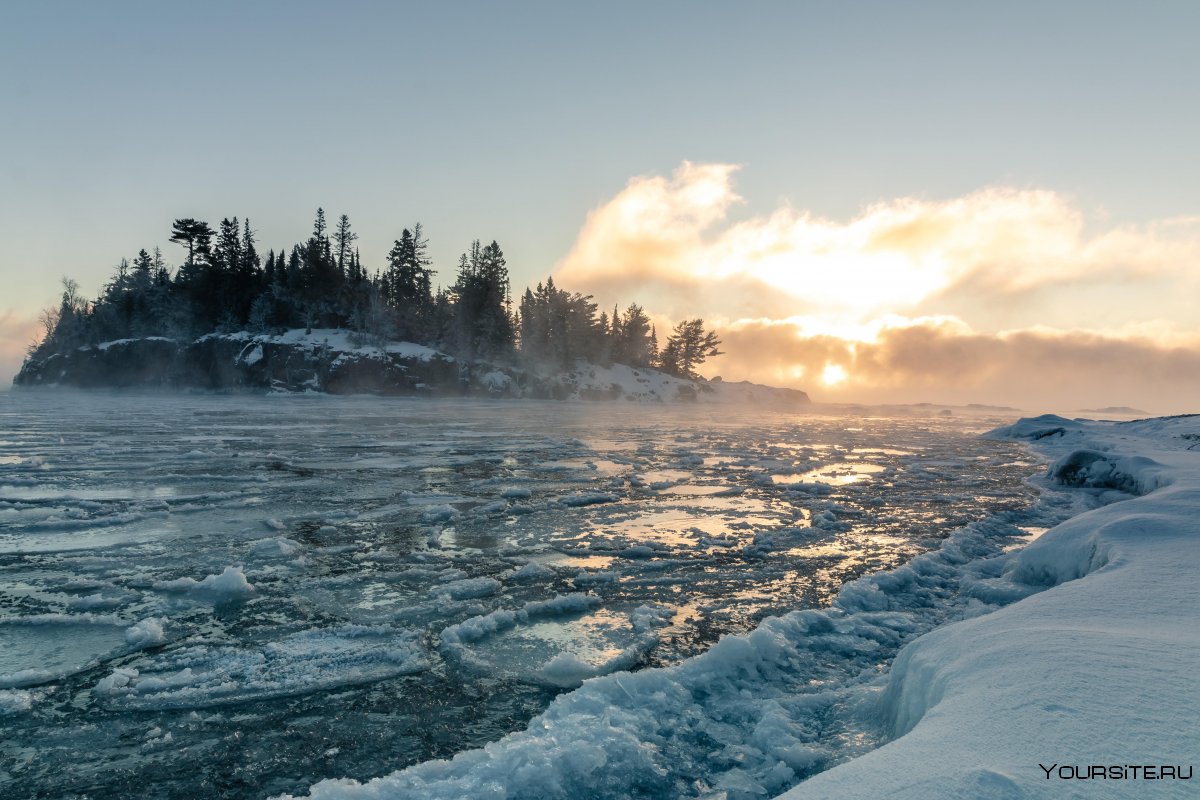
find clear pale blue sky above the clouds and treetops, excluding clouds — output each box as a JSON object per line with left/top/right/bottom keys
{"left": 0, "top": 1, "right": 1200, "bottom": 407}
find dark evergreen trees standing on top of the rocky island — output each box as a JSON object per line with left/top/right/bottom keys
{"left": 31, "top": 209, "right": 720, "bottom": 378}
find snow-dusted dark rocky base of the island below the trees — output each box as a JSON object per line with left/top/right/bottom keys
{"left": 13, "top": 330, "right": 809, "bottom": 405}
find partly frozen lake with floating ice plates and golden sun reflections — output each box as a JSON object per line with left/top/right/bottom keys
{"left": 0, "top": 392, "right": 1068, "bottom": 800}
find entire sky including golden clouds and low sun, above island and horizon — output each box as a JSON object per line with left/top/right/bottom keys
{"left": 0, "top": 0, "right": 1200, "bottom": 413}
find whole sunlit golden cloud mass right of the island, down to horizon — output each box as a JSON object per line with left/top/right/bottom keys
{"left": 556, "top": 162, "right": 1200, "bottom": 409}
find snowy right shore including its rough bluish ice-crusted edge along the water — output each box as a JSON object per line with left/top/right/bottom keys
{"left": 272, "top": 416, "right": 1200, "bottom": 800}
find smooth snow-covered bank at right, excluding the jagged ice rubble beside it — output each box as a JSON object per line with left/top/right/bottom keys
{"left": 782, "top": 416, "right": 1200, "bottom": 800}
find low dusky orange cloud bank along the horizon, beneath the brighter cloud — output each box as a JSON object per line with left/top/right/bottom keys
{"left": 713, "top": 319, "right": 1200, "bottom": 411}
